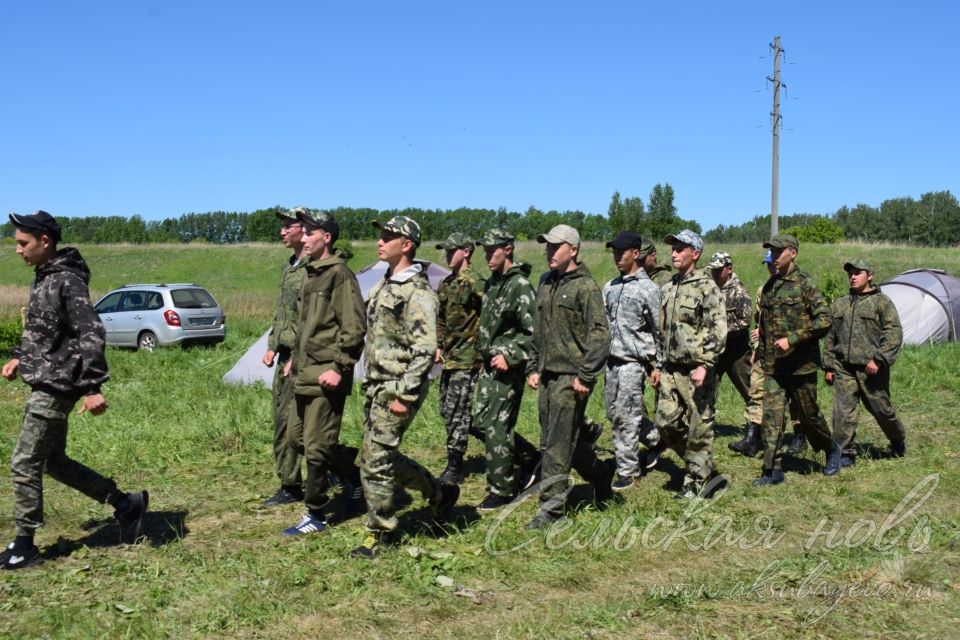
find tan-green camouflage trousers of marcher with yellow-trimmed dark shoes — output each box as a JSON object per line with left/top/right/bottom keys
{"left": 360, "top": 382, "right": 440, "bottom": 532}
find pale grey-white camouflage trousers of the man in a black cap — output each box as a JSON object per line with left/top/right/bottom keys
{"left": 603, "top": 362, "right": 660, "bottom": 478}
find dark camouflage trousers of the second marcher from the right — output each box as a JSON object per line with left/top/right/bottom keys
{"left": 762, "top": 373, "right": 832, "bottom": 470}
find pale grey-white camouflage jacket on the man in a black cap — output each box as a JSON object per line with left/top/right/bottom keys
{"left": 603, "top": 269, "right": 660, "bottom": 365}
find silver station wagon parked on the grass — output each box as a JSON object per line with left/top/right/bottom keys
{"left": 94, "top": 283, "right": 227, "bottom": 351}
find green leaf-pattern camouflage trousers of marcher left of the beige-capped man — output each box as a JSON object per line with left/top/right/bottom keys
{"left": 473, "top": 365, "right": 540, "bottom": 498}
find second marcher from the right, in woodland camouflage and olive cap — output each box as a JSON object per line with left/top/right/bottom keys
{"left": 754, "top": 234, "right": 832, "bottom": 486}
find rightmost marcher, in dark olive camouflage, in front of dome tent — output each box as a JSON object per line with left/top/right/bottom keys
{"left": 823, "top": 259, "right": 907, "bottom": 467}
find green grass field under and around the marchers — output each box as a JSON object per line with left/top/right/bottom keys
{"left": 0, "top": 243, "right": 960, "bottom": 638}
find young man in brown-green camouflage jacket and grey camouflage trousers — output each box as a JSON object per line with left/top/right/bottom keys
{"left": 435, "top": 232, "right": 485, "bottom": 484}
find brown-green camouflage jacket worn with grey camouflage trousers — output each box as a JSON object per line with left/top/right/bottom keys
{"left": 437, "top": 265, "right": 484, "bottom": 370}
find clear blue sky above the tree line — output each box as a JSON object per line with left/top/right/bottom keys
{"left": 0, "top": 0, "right": 960, "bottom": 229}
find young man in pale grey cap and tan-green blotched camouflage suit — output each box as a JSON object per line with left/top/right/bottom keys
{"left": 651, "top": 229, "right": 727, "bottom": 499}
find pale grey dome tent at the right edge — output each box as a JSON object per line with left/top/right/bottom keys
{"left": 881, "top": 269, "right": 960, "bottom": 344}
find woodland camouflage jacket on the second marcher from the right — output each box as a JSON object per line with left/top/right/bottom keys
{"left": 756, "top": 268, "right": 830, "bottom": 375}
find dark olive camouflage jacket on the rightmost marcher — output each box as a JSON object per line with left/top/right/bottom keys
{"left": 823, "top": 287, "right": 903, "bottom": 371}
